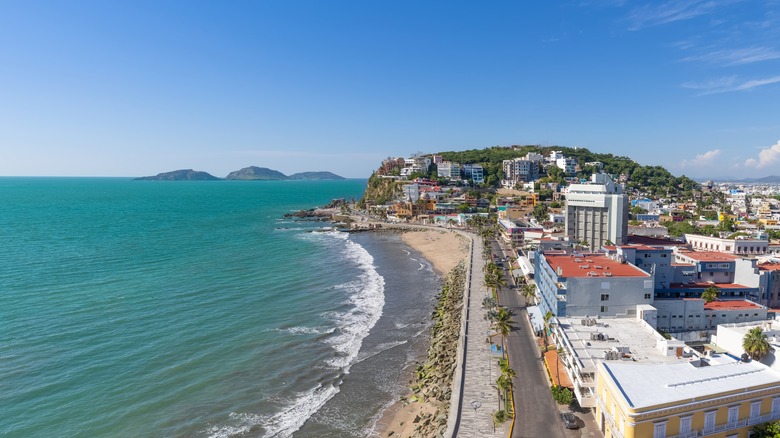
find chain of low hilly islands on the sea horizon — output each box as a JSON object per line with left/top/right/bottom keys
{"left": 135, "top": 166, "right": 345, "bottom": 181}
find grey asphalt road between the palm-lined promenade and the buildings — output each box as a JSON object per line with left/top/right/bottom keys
{"left": 493, "top": 243, "right": 568, "bottom": 438}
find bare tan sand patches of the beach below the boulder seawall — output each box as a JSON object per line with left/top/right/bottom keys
{"left": 372, "top": 230, "right": 469, "bottom": 437}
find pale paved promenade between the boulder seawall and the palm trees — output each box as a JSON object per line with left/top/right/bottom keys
{"left": 454, "top": 237, "right": 511, "bottom": 437}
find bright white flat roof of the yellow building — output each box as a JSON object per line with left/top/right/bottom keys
{"left": 603, "top": 360, "right": 780, "bottom": 409}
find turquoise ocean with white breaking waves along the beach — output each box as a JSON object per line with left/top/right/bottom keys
{"left": 0, "top": 178, "right": 439, "bottom": 437}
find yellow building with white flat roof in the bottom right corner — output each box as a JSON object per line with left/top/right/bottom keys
{"left": 596, "top": 355, "right": 780, "bottom": 438}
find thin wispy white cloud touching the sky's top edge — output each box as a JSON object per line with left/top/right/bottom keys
{"left": 628, "top": 0, "right": 738, "bottom": 30}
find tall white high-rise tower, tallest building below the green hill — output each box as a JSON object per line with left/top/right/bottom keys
{"left": 566, "top": 173, "right": 628, "bottom": 249}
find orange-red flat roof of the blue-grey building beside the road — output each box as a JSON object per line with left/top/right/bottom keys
{"left": 544, "top": 252, "right": 650, "bottom": 278}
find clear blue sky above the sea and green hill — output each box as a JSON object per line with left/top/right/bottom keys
{"left": 0, "top": 0, "right": 780, "bottom": 177}
